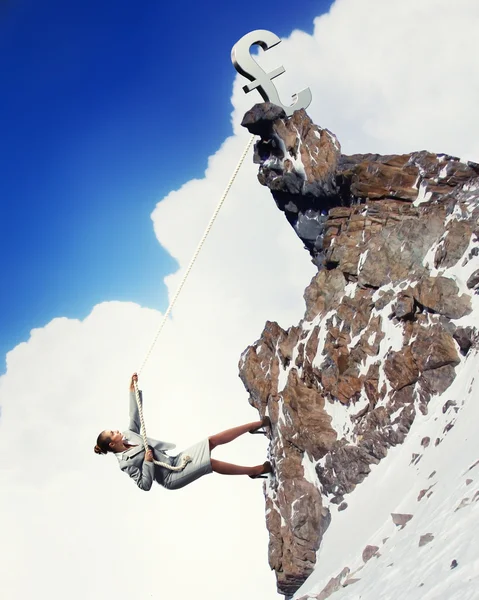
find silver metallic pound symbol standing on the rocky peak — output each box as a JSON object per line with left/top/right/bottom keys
{"left": 231, "top": 29, "right": 312, "bottom": 117}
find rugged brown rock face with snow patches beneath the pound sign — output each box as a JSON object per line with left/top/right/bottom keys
{"left": 240, "top": 103, "right": 479, "bottom": 596}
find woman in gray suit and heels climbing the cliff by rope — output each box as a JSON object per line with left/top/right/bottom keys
{"left": 95, "top": 373, "right": 272, "bottom": 491}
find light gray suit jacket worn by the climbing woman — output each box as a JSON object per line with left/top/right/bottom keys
{"left": 117, "top": 391, "right": 175, "bottom": 491}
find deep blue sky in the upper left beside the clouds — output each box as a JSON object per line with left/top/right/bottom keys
{"left": 0, "top": 0, "right": 330, "bottom": 372}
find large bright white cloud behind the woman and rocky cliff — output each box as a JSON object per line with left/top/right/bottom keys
{"left": 0, "top": 0, "right": 479, "bottom": 600}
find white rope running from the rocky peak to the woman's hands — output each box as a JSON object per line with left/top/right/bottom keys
{"left": 134, "top": 135, "right": 255, "bottom": 471}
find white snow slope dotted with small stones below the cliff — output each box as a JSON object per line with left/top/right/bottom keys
{"left": 294, "top": 350, "right": 479, "bottom": 600}
